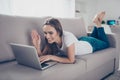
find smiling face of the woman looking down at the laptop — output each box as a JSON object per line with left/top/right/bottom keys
{"left": 43, "top": 25, "right": 59, "bottom": 43}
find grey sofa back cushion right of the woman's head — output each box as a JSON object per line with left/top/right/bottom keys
{"left": 58, "top": 18, "right": 87, "bottom": 38}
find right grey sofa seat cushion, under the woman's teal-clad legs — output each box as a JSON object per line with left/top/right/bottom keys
{"left": 78, "top": 48, "right": 116, "bottom": 71}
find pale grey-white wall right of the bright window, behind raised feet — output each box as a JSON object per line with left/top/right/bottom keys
{"left": 76, "top": 0, "right": 120, "bottom": 26}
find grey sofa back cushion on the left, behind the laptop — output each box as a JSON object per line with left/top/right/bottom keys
{"left": 0, "top": 15, "right": 44, "bottom": 62}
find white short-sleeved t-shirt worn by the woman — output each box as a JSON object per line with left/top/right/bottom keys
{"left": 61, "top": 31, "right": 93, "bottom": 55}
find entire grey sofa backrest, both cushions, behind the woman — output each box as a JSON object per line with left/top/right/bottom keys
{"left": 0, "top": 15, "right": 87, "bottom": 62}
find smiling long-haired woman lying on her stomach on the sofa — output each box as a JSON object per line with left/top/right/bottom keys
{"left": 31, "top": 12, "right": 109, "bottom": 63}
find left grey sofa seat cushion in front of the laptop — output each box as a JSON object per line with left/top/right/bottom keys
{"left": 0, "top": 59, "right": 86, "bottom": 80}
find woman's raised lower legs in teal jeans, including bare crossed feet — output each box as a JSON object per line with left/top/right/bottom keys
{"left": 91, "top": 12, "right": 109, "bottom": 51}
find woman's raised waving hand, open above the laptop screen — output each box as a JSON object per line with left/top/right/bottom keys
{"left": 31, "top": 30, "right": 41, "bottom": 48}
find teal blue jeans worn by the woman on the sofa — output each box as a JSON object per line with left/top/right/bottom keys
{"left": 78, "top": 27, "right": 109, "bottom": 52}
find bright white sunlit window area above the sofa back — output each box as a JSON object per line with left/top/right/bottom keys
{"left": 11, "top": 0, "right": 75, "bottom": 17}
